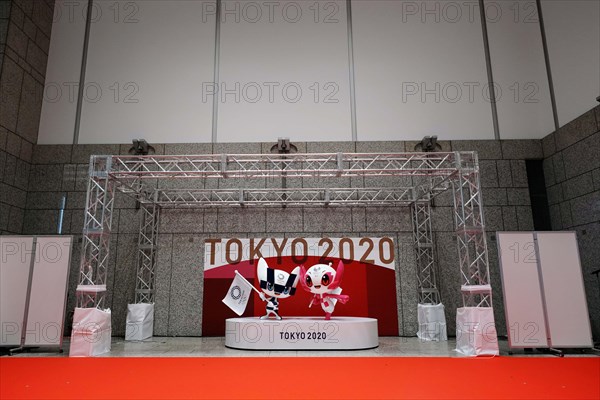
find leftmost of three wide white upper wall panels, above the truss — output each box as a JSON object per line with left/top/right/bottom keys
{"left": 79, "top": 0, "right": 216, "bottom": 143}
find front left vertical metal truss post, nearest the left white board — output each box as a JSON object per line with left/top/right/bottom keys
{"left": 76, "top": 156, "right": 115, "bottom": 308}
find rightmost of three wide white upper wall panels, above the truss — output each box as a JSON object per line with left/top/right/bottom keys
{"left": 352, "top": 1, "right": 494, "bottom": 140}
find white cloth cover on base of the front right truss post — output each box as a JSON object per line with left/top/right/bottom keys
{"left": 456, "top": 307, "right": 499, "bottom": 356}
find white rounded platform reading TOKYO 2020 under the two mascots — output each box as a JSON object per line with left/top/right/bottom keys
{"left": 225, "top": 317, "right": 379, "bottom": 350}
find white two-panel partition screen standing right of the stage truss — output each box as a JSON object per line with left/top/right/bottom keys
{"left": 497, "top": 232, "right": 593, "bottom": 348}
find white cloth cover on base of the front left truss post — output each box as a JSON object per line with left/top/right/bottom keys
{"left": 69, "top": 308, "right": 112, "bottom": 357}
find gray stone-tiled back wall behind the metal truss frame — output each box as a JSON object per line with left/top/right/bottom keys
{"left": 23, "top": 140, "right": 543, "bottom": 336}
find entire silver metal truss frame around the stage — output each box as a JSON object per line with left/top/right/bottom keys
{"left": 77, "top": 152, "right": 492, "bottom": 320}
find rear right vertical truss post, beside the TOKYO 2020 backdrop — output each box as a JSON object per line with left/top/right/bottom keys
{"left": 411, "top": 201, "right": 440, "bottom": 304}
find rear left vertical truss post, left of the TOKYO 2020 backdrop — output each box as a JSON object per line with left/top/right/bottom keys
{"left": 135, "top": 200, "right": 160, "bottom": 304}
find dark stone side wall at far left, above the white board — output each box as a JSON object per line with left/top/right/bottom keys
{"left": 0, "top": 0, "right": 54, "bottom": 234}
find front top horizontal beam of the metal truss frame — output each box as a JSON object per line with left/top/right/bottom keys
{"left": 111, "top": 153, "right": 456, "bottom": 180}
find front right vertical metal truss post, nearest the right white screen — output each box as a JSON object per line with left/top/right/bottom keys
{"left": 452, "top": 152, "right": 492, "bottom": 307}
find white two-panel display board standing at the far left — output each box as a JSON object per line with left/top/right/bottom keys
{"left": 0, "top": 236, "right": 72, "bottom": 347}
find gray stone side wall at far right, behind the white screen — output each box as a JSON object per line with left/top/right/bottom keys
{"left": 542, "top": 106, "right": 600, "bottom": 340}
